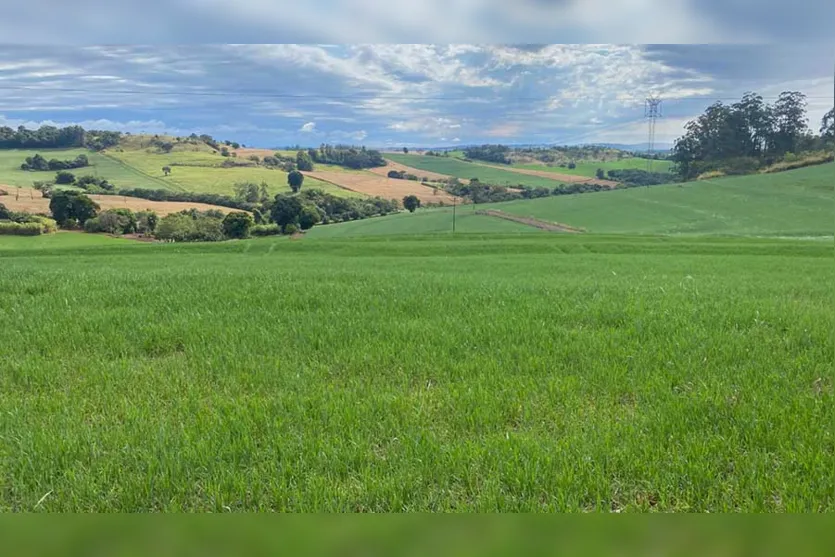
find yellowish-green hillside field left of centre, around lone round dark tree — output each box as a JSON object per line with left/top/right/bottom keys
{"left": 109, "top": 150, "right": 361, "bottom": 197}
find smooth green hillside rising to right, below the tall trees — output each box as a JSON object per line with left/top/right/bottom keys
{"left": 313, "top": 164, "right": 835, "bottom": 237}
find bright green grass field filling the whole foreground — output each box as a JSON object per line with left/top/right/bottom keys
{"left": 0, "top": 234, "right": 835, "bottom": 511}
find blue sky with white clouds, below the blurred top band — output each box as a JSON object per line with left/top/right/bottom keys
{"left": 0, "top": 43, "right": 835, "bottom": 147}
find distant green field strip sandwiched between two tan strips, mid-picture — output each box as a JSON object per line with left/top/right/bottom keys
{"left": 385, "top": 153, "right": 562, "bottom": 188}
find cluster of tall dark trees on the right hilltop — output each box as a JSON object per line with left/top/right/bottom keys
{"left": 672, "top": 91, "right": 835, "bottom": 180}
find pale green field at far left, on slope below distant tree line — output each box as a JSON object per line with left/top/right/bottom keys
{"left": 0, "top": 149, "right": 170, "bottom": 189}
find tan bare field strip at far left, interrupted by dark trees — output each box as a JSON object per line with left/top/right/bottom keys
{"left": 0, "top": 190, "right": 242, "bottom": 217}
